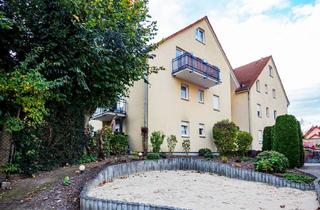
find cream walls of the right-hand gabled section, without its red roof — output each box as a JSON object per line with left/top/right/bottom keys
{"left": 232, "top": 57, "right": 289, "bottom": 150}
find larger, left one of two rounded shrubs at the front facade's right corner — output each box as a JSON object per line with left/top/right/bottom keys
{"left": 212, "top": 120, "right": 239, "bottom": 154}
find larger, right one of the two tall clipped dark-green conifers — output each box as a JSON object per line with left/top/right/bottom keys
{"left": 272, "top": 115, "right": 301, "bottom": 168}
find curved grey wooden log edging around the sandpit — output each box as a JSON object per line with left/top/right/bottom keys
{"left": 80, "top": 158, "right": 320, "bottom": 210}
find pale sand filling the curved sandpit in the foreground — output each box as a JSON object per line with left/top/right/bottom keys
{"left": 89, "top": 171, "right": 318, "bottom": 210}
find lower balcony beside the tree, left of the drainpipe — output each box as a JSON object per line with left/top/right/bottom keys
{"left": 92, "top": 100, "right": 127, "bottom": 122}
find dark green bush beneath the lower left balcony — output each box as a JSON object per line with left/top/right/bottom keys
{"left": 109, "top": 133, "right": 129, "bottom": 155}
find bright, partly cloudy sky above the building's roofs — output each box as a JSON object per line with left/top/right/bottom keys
{"left": 149, "top": 0, "right": 320, "bottom": 129}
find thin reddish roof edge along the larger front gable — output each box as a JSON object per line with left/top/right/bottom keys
{"left": 157, "top": 16, "right": 240, "bottom": 88}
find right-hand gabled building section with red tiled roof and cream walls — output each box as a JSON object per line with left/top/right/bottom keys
{"left": 232, "top": 56, "right": 290, "bottom": 150}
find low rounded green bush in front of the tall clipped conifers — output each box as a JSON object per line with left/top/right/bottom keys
{"left": 254, "top": 151, "right": 289, "bottom": 173}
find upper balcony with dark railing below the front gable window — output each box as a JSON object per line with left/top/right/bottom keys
{"left": 172, "top": 52, "right": 221, "bottom": 88}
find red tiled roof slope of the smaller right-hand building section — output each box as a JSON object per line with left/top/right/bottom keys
{"left": 234, "top": 56, "right": 271, "bottom": 91}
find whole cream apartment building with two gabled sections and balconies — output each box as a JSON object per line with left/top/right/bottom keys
{"left": 93, "top": 17, "right": 289, "bottom": 152}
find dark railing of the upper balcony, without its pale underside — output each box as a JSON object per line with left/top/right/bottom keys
{"left": 172, "top": 52, "right": 220, "bottom": 81}
